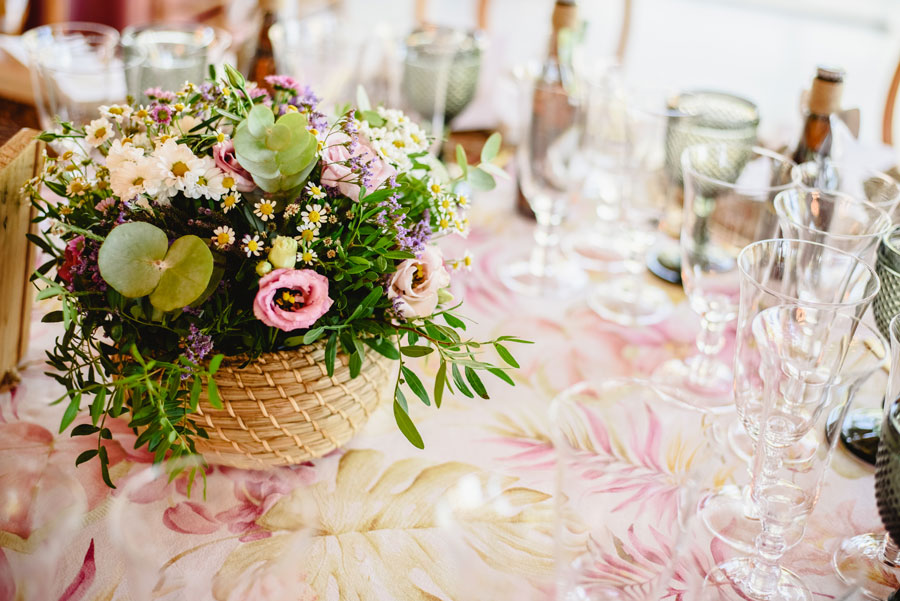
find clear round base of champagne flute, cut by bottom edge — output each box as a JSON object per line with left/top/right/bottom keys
{"left": 700, "top": 557, "right": 812, "bottom": 601}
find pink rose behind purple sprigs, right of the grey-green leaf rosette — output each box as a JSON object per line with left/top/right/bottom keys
{"left": 321, "top": 132, "right": 397, "bottom": 202}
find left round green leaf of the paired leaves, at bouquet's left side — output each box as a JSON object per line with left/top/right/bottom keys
{"left": 97, "top": 221, "right": 169, "bottom": 298}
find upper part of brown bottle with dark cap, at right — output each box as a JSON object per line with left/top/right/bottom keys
{"left": 792, "top": 67, "right": 844, "bottom": 165}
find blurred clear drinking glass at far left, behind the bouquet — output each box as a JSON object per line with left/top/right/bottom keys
{"left": 22, "top": 22, "right": 126, "bottom": 130}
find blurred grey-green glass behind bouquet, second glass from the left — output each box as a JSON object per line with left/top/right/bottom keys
{"left": 122, "top": 24, "right": 222, "bottom": 103}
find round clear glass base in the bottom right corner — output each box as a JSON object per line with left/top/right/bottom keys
{"left": 831, "top": 532, "right": 900, "bottom": 601}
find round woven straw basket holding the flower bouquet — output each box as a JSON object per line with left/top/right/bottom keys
{"left": 195, "top": 342, "right": 393, "bottom": 469}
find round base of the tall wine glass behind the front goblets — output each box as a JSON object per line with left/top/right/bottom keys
{"left": 653, "top": 356, "right": 734, "bottom": 412}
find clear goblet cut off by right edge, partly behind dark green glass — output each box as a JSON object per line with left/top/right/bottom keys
{"left": 831, "top": 315, "right": 900, "bottom": 600}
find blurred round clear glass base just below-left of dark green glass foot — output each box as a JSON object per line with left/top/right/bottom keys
{"left": 588, "top": 276, "right": 674, "bottom": 326}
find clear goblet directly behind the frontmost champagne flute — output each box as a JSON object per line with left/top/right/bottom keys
{"left": 700, "top": 239, "right": 879, "bottom": 549}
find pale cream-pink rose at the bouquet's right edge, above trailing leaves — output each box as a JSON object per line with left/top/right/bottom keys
{"left": 388, "top": 246, "right": 450, "bottom": 317}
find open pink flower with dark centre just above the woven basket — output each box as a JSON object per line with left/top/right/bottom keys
{"left": 253, "top": 269, "right": 334, "bottom": 332}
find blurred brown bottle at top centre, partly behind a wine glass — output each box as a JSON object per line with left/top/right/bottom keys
{"left": 516, "top": 0, "right": 578, "bottom": 219}
